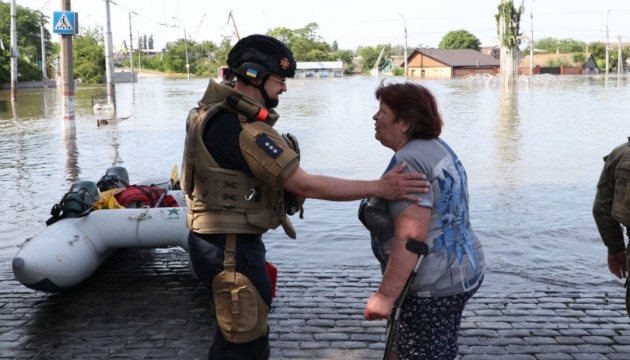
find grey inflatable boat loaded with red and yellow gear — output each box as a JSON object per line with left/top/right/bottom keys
{"left": 12, "top": 168, "right": 188, "bottom": 292}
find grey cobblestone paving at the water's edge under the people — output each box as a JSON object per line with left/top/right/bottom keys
{"left": 0, "top": 248, "right": 630, "bottom": 360}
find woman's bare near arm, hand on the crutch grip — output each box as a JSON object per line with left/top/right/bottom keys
{"left": 363, "top": 204, "right": 431, "bottom": 320}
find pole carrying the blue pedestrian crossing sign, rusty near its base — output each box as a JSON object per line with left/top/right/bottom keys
{"left": 59, "top": 0, "right": 76, "bottom": 122}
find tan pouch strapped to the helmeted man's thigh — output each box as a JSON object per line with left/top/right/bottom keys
{"left": 212, "top": 234, "right": 269, "bottom": 344}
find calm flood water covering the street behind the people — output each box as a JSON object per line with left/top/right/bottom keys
{"left": 0, "top": 75, "right": 630, "bottom": 287}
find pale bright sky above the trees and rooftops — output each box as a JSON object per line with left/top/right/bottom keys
{"left": 13, "top": 0, "right": 630, "bottom": 50}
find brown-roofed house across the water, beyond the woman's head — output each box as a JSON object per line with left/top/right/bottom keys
{"left": 408, "top": 49, "right": 501, "bottom": 79}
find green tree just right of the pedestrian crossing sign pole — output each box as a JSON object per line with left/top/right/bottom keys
{"left": 72, "top": 28, "right": 106, "bottom": 83}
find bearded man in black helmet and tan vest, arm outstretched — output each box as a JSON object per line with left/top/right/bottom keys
{"left": 181, "top": 35, "right": 428, "bottom": 360}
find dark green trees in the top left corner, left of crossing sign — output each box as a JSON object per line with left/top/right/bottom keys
{"left": 0, "top": 2, "right": 52, "bottom": 83}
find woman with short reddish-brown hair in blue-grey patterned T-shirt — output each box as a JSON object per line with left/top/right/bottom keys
{"left": 359, "top": 82, "right": 485, "bottom": 360}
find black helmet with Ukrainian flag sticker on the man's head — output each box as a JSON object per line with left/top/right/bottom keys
{"left": 227, "top": 35, "right": 296, "bottom": 80}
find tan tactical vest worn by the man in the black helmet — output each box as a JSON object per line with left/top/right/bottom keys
{"left": 181, "top": 90, "right": 299, "bottom": 239}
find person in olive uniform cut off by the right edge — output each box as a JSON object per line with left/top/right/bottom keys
{"left": 593, "top": 137, "right": 630, "bottom": 316}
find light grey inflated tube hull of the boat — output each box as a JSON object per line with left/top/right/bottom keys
{"left": 12, "top": 200, "right": 188, "bottom": 292}
